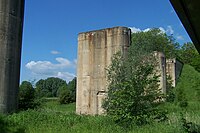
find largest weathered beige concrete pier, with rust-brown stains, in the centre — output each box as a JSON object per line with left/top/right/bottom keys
{"left": 76, "top": 27, "right": 131, "bottom": 115}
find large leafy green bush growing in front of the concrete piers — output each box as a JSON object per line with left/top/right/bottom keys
{"left": 103, "top": 48, "right": 166, "bottom": 126}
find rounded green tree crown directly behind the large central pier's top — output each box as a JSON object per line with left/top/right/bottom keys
{"left": 131, "top": 28, "right": 180, "bottom": 58}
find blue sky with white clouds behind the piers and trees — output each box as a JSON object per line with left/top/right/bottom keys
{"left": 21, "top": 0, "right": 191, "bottom": 81}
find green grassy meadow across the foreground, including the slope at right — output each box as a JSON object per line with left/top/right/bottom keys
{"left": 0, "top": 65, "right": 200, "bottom": 133}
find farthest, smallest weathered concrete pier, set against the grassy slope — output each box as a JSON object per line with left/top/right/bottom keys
{"left": 166, "top": 58, "right": 183, "bottom": 87}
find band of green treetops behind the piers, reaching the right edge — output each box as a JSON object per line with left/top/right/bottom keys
{"left": 131, "top": 28, "right": 200, "bottom": 72}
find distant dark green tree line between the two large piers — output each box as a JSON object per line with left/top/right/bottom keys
{"left": 19, "top": 77, "right": 76, "bottom": 110}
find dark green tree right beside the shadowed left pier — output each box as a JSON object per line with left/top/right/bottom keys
{"left": 19, "top": 81, "right": 35, "bottom": 110}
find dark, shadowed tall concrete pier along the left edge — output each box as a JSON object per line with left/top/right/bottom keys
{"left": 0, "top": 0, "right": 24, "bottom": 113}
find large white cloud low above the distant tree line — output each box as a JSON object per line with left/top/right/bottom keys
{"left": 26, "top": 57, "right": 76, "bottom": 82}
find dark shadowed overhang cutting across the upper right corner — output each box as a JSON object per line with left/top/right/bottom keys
{"left": 170, "top": 0, "right": 200, "bottom": 53}
